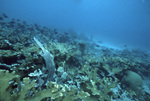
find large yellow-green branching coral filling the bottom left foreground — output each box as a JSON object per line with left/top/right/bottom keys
{"left": 0, "top": 70, "right": 90, "bottom": 101}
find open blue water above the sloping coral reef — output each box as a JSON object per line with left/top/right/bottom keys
{"left": 0, "top": 0, "right": 150, "bottom": 51}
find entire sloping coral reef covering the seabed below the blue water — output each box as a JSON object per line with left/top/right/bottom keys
{"left": 0, "top": 14, "right": 150, "bottom": 101}
